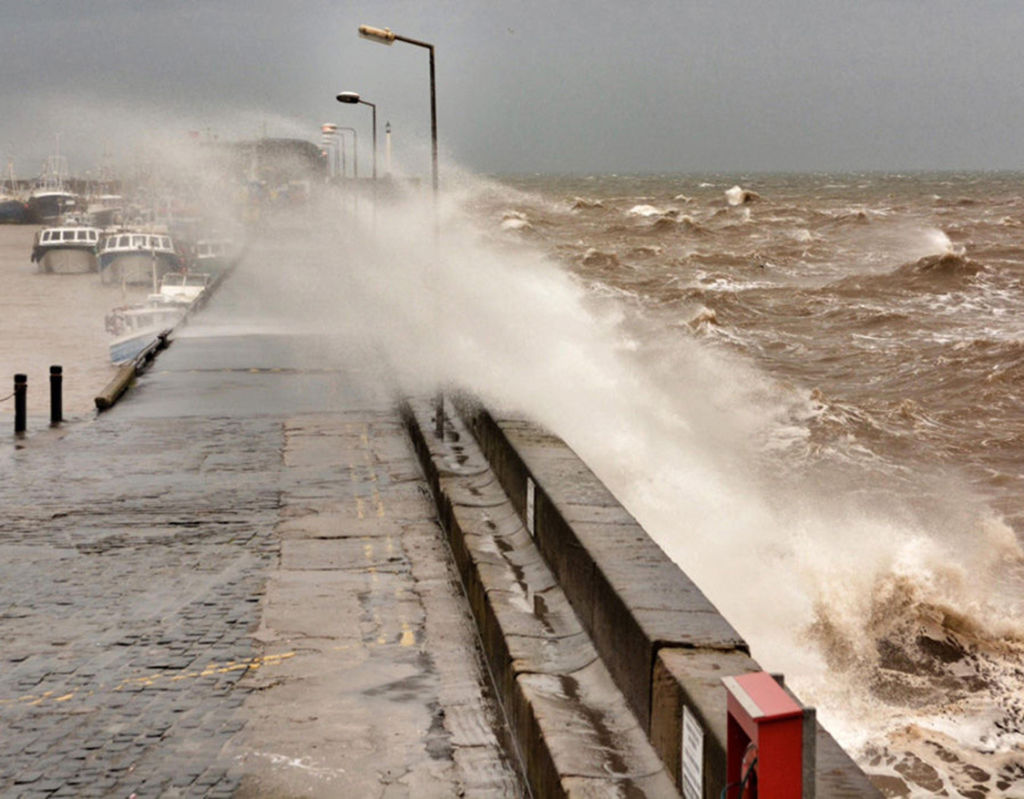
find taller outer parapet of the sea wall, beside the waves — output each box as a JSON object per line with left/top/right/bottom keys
{"left": 455, "top": 396, "right": 881, "bottom": 799}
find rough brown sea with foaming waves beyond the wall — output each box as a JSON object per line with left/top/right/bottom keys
{"left": 471, "top": 174, "right": 1024, "bottom": 796}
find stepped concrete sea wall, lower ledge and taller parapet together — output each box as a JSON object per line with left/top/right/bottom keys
{"left": 406, "top": 397, "right": 881, "bottom": 799}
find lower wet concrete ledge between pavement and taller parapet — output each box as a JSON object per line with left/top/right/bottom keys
{"left": 402, "top": 403, "right": 679, "bottom": 798}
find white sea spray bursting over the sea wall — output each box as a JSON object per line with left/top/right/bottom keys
{"left": 241, "top": 169, "right": 1021, "bottom": 790}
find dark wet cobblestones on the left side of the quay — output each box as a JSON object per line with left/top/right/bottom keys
{"left": 0, "top": 414, "right": 284, "bottom": 797}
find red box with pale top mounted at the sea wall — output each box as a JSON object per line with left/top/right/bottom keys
{"left": 722, "top": 671, "right": 814, "bottom": 799}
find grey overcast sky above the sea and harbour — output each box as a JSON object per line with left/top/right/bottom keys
{"left": 0, "top": 0, "right": 1024, "bottom": 175}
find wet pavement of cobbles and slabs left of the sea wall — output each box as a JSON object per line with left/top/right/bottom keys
{"left": 0, "top": 266, "right": 522, "bottom": 797}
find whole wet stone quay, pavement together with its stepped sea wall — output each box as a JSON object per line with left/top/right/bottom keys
{"left": 0, "top": 253, "right": 880, "bottom": 797}
